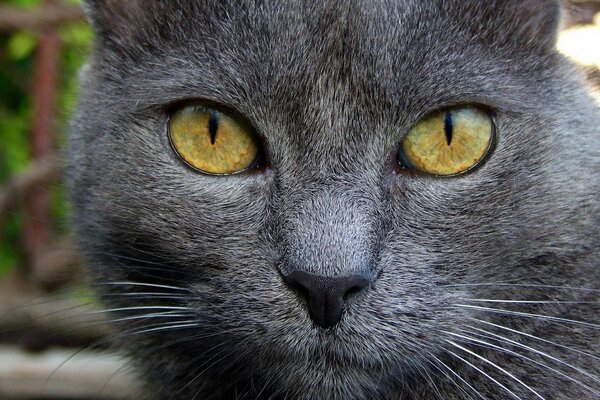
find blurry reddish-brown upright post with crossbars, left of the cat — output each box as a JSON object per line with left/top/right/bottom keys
{"left": 0, "top": 0, "right": 84, "bottom": 288}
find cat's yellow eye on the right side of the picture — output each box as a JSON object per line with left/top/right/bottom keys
{"left": 399, "top": 107, "right": 494, "bottom": 176}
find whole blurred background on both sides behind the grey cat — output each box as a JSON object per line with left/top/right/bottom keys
{"left": 0, "top": 0, "right": 600, "bottom": 400}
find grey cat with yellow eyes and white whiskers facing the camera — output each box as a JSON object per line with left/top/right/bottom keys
{"left": 70, "top": 0, "right": 600, "bottom": 400}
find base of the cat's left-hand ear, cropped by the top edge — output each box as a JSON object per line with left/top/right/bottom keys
{"left": 83, "top": 0, "right": 150, "bottom": 41}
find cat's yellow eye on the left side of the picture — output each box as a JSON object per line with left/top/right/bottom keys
{"left": 169, "top": 106, "right": 260, "bottom": 175}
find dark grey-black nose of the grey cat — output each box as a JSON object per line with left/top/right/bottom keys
{"left": 285, "top": 270, "right": 370, "bottom": 328}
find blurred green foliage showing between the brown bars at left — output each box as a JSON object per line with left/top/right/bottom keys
{"left": 0, "top": 0, "right": 92, "bottom": 276}
